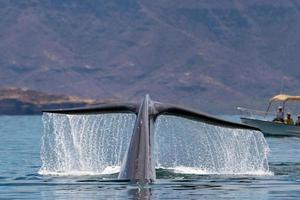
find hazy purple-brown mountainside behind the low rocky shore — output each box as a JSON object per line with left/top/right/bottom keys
{"left": 0, "top": 0, "right": 300, "bottom": 112}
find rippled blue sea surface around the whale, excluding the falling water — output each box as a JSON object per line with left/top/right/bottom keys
{"left": 0, "top": 116, "right": 300, "bottom": 200}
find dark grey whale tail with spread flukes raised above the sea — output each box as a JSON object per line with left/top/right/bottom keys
{"left": 43, "top": 95, "right": 258, "bottom": 182}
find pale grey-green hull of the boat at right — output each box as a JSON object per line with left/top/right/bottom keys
{"left": 241, "top": 117, "right": 300, "bottom": 137}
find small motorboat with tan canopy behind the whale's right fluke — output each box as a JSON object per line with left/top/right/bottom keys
{"left": 238, "top": 94, "right": 300, "bottom": 137}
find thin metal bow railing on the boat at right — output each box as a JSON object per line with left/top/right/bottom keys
{"left": 237, "top": 107, "right": 275, "bottom": 120}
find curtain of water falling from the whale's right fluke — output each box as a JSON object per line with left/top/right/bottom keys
{"left": 155, "top": 115, "right": 271, "bottom": 175}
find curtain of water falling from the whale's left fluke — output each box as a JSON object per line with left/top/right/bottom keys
{"left": 39, "top": 113, "right": 136, "bottom": 175}
